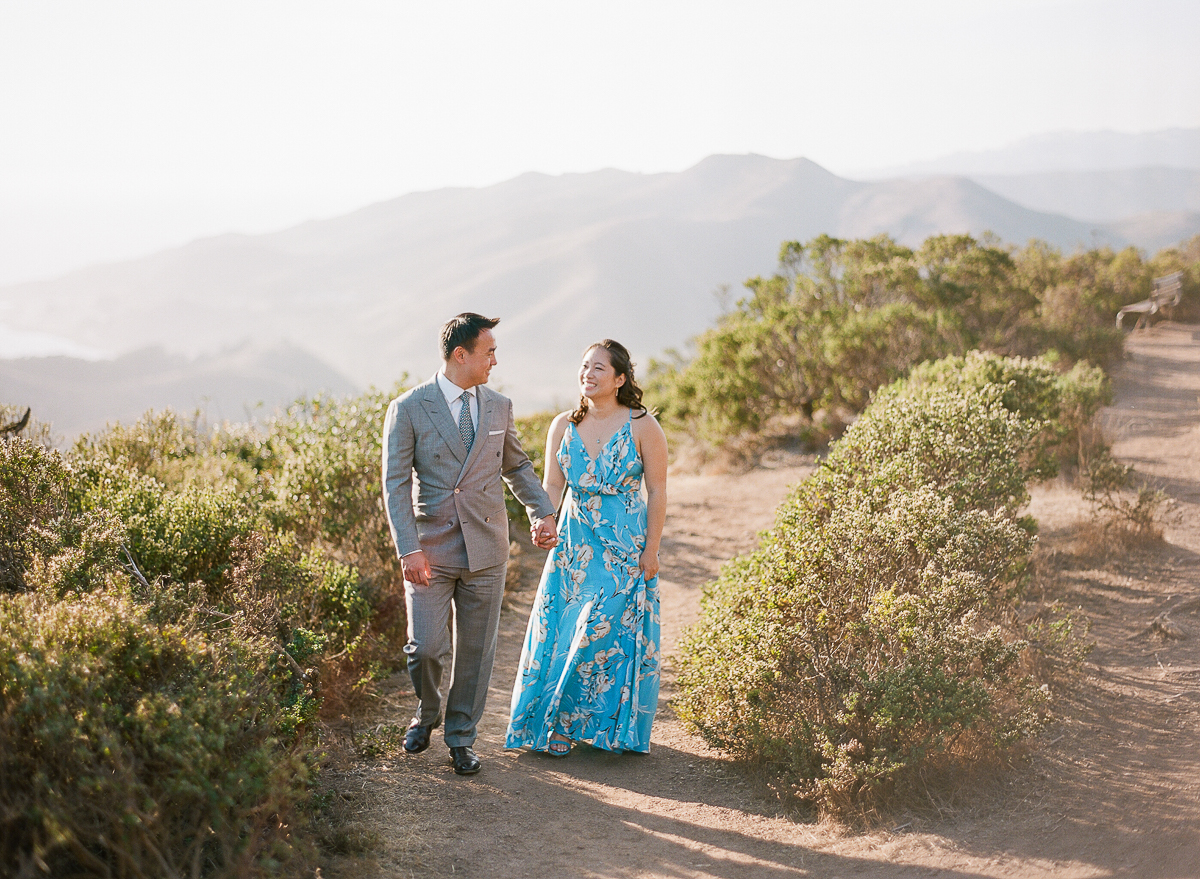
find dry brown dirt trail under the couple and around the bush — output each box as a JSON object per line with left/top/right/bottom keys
{"left": 323, "top": 324, "right": 1200, "bottom": 879}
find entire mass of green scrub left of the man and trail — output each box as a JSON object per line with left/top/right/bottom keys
{"left": 0, "top": 393, "right": 404, "bottom": 877}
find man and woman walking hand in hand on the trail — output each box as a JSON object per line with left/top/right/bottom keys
{"left": 383, "top": 312, "right": 667, "bottom": 776}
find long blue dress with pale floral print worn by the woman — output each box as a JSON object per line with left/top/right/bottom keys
{"left": 505, "top": 421, "right": 659, "bottom": 752}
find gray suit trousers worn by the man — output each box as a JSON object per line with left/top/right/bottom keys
{"left": 404, "top": 562, "right": 508, "bottom": 748}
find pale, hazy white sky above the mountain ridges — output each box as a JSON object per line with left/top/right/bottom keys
{"left": 0, "top": 0, "right": 1200, "bottom": 283}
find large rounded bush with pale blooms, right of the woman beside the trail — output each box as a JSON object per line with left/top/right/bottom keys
{"left": 679, "top": 360, "right": 1084, "bottom": 815}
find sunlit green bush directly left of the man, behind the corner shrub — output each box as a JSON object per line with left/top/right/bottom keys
{"left": 74, "top": 389, "right": 404, "bottom": 691}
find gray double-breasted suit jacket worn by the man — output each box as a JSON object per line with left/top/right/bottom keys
{"left": 383, "top": 376, "right": 554, "bottom": 570}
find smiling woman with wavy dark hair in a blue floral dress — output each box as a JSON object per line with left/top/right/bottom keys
{"left": 505, "top": 339, "right": 667, "bottom": 757}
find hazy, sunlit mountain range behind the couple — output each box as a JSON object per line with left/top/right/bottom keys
{"left": 0, "top": 142, "right": 1200, "bottom": 434}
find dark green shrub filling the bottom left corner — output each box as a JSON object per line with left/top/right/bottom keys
{"left": 0, "top": 591, "right": 306, "bottom": 877}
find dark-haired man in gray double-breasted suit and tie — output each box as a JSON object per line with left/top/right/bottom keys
{"left": 383, "top": 312, "right": 557, "bottom": 776}
